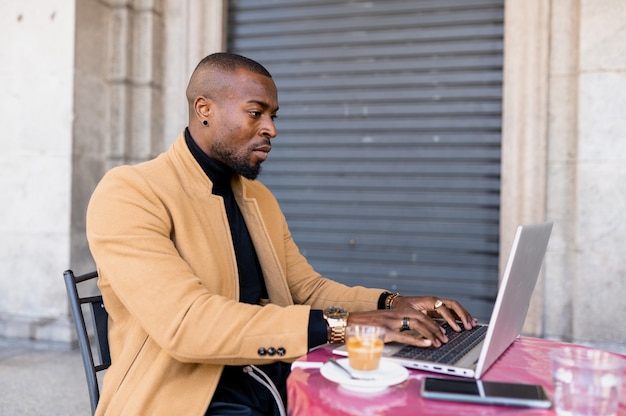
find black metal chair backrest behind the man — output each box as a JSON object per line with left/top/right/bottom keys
{"left": 63, "top": 270, "right": 111, "bottom": 413}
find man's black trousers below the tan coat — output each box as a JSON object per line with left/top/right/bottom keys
{"left": 206, "top": 362, "right": 291, "bottom": 416}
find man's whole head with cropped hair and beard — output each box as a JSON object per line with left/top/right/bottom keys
{"left": 182, "top": 53, "right": 278, "bottom": 179}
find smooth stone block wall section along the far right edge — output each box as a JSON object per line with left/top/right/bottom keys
{"left": 572, "top": 0, "right": 626, "bottom": 353}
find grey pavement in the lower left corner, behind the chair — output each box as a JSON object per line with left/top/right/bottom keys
{"left": 0, "top": 339, "right": 91, "bottom": 416}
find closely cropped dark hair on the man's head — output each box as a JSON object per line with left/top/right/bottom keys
{"left": 187, "top": 52, "right": 272, "bottom": 110}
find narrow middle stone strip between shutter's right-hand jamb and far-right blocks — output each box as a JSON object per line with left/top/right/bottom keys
{"left": 543, "top": 0, "right": 580, "bottom": 340}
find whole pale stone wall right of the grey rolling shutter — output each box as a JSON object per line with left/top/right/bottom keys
{"left": 501, "top": 0, "right": 626, "bottom": 354}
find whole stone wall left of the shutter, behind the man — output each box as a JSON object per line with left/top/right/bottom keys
{"left": 0, "top": 0, "right": 226, "bottom": 346}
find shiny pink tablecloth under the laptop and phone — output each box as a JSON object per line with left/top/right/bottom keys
{"left": 287, "top": 337, "right": 626, "bottom": 416}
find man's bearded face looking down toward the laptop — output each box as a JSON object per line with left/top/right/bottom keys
{"left": 208, "top": 71, "right": 278, "bottom": 179}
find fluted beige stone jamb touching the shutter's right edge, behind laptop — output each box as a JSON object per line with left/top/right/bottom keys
{"left": 500, "top": 0, "right": 550, "bottom": 334}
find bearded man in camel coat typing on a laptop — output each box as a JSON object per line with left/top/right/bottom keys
{"left": 87, "top": 53, "right": 476, "bottom": 415}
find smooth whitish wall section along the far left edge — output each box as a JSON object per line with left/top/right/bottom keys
{"left": 0, "top": 0, "right": 75, "bottom": 341}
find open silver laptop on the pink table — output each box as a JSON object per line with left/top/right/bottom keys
{"left": 334, "top": 222, "right": 552, "bottom": 379}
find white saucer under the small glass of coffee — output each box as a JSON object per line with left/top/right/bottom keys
{"left": 320, "top": 358, "right": 409, "bottom": 392}
